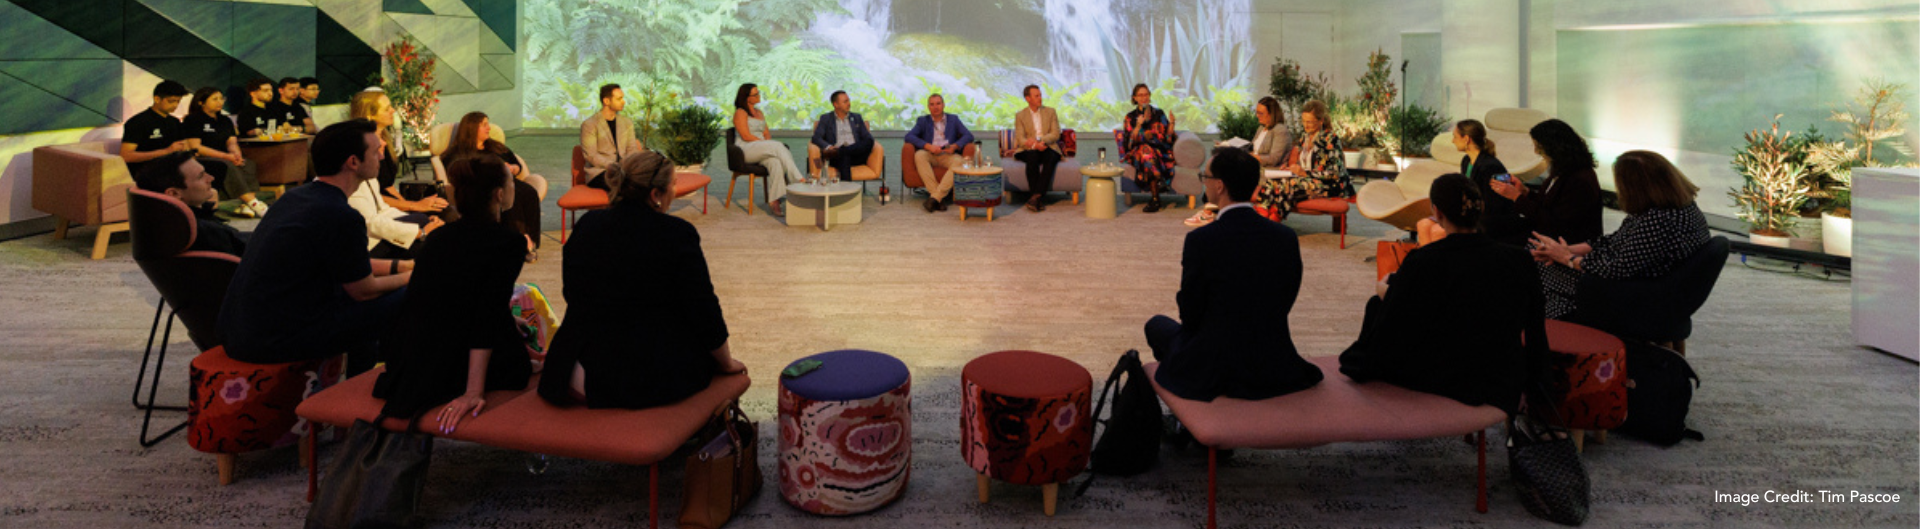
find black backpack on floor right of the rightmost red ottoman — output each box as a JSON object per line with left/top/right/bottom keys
{"left": 1613, "top": 339, "right": 1707, "bottom": 447}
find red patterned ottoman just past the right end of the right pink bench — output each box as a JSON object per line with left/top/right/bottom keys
{"left": 1530, "top": 320, "right": 1626, "bottom": 449}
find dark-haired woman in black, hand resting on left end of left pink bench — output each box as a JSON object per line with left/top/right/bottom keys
{"left": 374, "top": 155, "right": 534, "bottom": 431}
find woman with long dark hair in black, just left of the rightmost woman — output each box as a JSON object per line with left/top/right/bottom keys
{"left": 1492, "top": 119, "right": 1601, "bottom": 243}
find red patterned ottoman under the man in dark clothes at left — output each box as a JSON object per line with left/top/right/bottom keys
{"left": 186, "top": 347, "right": 344, "bottom": 485}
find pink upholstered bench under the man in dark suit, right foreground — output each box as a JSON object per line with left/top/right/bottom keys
{"left": 1146, "top": 357, "right": 1507, "bottom": 529}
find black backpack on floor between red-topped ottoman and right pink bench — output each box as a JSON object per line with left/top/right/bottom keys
{"left": 1081, "top": 351, "right": 1165, "bottom": 493}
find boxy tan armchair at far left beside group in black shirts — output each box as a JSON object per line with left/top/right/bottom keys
{"left": 33, "top": 142, "right": 132, "bottom": 259}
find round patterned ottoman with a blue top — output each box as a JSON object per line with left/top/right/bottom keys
{"left": 780, "top": 349, "right": 914, "bottom": 516}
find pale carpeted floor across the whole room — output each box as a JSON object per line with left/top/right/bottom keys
{"left": 0, "top": 136, "right": 1920, "bottom": 527}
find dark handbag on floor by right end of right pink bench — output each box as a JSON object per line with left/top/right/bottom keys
{"left": 1507, "top": 416, "right": 1592, "bottom": 525}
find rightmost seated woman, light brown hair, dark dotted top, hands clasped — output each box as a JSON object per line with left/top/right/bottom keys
{"left": 1534, "top": 151, "right": 1713, "bottom": 320}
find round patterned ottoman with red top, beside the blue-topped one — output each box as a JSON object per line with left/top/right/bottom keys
{"left": 960, "top": 351, "right": 1092, "bottom": 516}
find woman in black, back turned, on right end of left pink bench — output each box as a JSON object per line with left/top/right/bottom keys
{"left": 541, "top": 151, "right": 747, "bottom": 408}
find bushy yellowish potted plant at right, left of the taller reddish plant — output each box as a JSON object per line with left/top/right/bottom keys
{"left": 1728, "top": 115, "right": 1809, "bottom": 247}
